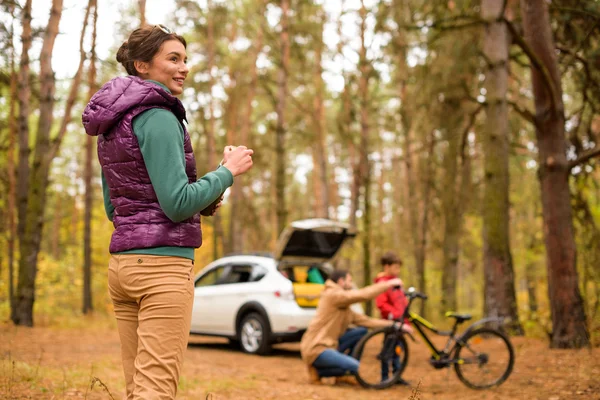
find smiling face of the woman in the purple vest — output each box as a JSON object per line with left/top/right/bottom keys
{"left": 140, "top": 40, "right": 189, "bottom": 96}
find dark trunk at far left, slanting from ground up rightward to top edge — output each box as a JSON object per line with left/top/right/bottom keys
{"left": 13, "top": 0, "right": 62, "bottom": 326}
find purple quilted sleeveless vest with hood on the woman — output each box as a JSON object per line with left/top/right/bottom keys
{"left": 83, "top": 76, "right": 202, "bottom": 253}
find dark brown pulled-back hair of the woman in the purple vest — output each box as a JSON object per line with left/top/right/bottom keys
{"left": 117, "top": 25, "right": 187, "bottom": 76}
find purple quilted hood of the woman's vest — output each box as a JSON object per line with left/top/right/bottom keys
{"left": 82, "top": 75, "right": 185, "bottom": 136}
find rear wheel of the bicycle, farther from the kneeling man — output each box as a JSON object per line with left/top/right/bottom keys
{"left": 454, "top": 328, "right": 515, "bottom": 389}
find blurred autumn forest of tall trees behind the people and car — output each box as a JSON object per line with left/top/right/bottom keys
{"left": 0, "top": 0, "right": 600, "bottom": 348}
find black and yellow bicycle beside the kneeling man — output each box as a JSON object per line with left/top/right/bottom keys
{"left": 352, "top": 287, "right": 514, "bottom": 389}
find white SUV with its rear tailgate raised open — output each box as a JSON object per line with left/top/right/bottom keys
{"left": 191, "top": 219, "right": 362, "bottom": 354}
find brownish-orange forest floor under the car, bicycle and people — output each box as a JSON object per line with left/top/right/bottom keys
{"left": 0, "top": 318, "right": 600, "bottom": 400}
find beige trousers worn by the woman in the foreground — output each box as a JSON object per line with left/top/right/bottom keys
{"left": 108, "top": 254, "right": 194, "bottom": 400}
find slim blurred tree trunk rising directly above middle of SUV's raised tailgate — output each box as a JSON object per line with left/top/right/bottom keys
{"left": 312, "top": 15, "right": 329, "bottom": 218}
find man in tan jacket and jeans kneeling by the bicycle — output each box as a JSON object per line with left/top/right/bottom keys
{"left": 300, "top": 270, "right": 402, "bottom": 383}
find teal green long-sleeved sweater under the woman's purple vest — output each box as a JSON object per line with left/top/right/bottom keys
{"left": 102, "top": 81, "right": 233, "bottom": 260}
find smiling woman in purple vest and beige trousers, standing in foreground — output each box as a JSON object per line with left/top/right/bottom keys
{"left": 83, "top": 25, "right": 252, "bottom": 399}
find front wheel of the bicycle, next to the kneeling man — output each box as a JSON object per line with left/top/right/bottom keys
{"left": 352, "top": 328, "right": 408, "bottom": 389}
